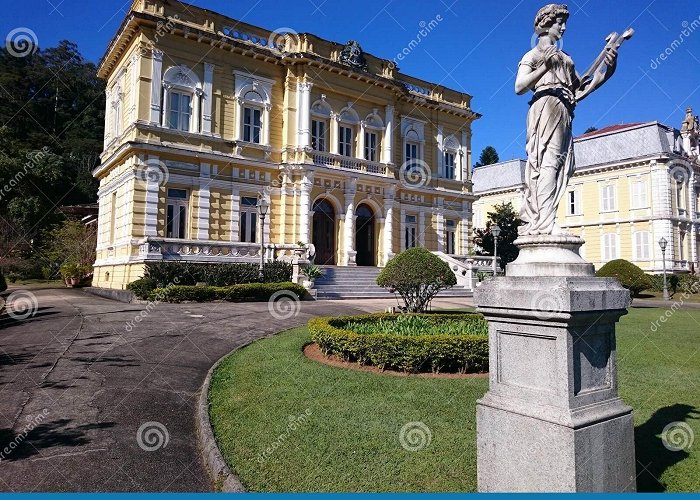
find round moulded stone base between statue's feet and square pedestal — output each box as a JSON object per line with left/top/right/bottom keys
{"left": 506, "top": 234, "right": 595, "bottom": 276}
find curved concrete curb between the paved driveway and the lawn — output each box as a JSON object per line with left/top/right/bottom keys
{"left": 197, "top": 349, "right": 245, "bottom": 493}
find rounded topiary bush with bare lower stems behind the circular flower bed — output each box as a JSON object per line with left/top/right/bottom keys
{"left": 377, "top": 247, "right": 457, "bottom": 312}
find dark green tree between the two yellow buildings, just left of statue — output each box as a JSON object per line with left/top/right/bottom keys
{"left": 474, "top": 202, "right": 523, "bottom": 270}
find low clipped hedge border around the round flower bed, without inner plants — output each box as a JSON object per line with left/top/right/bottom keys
{"left": 309, "top": 314, "right": 489, "bottom": 373}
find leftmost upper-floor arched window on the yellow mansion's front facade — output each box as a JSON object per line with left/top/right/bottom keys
{"left": 161, "top": 64, "right": 202, "bottom": 132}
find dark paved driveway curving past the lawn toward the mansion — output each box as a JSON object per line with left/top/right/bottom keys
{"left": 0, "top": 289, "right": 400, "bottom": 491}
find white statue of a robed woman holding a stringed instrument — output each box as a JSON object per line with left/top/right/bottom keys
{"left": 515, "top": 4, "right": 634, "bottom": 236}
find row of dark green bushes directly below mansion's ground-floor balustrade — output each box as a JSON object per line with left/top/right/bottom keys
{"left": 144, "top": 261, "right": 292, "bottom": 287}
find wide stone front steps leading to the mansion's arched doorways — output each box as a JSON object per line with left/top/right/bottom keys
{"left": 315, "top": 266, "right": 472, "bottom": 300}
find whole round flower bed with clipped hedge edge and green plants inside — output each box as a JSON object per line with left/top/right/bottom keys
{"left": 309, "top": 314, "right": 489, "bottom": 373}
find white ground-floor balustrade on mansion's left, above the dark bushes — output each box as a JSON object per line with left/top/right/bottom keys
{"left": 138, "top": 236, "right": 313, "bottom": 263}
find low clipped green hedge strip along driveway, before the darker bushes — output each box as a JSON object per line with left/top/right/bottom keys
{"left": 148, "top": 282, "right": 306, "bottom": 302}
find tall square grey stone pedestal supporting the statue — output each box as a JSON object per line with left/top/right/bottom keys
{"left": 474, "top": 236, "right": 636, "bottom": 492}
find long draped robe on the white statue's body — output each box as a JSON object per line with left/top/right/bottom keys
{"left": 519, "top": 47, "right": 578, "bottom": 235}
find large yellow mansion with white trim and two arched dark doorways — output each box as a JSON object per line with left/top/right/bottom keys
{"left": 93, "top": 0, "right": 480, "bottom": 288}
